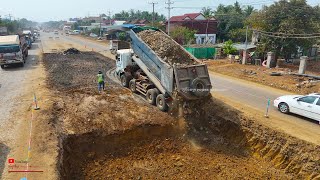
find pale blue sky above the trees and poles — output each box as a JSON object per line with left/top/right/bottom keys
{"left": 0, "top": 0, "right": 320, "bottom": 22}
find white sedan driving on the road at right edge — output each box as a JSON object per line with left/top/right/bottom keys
{"left": 274, "top": 93, "right": 320, "bottom": 123}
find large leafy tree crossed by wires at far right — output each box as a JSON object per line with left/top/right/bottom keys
{"left": 247, "top": 0, "right": 320, "bottom": 58}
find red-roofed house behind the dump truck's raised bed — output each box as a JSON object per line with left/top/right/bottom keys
{"left": 166, "top": 13, "right": 218, "bottom": 44}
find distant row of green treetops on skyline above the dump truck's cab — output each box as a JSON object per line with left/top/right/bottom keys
{"left": 113, "top": 9, "right": 166, "bottom": 22}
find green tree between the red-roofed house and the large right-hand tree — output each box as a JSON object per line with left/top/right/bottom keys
{"left": 214, "top": 1, "right": 253, "bottom": 41}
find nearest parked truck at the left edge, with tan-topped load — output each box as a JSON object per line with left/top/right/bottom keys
{"left": 0, "top": 35, "right": 28, "bottom": 69}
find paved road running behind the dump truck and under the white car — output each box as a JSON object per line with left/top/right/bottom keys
{"left": 45, "top": 32, "right": 320, "bottom": 144}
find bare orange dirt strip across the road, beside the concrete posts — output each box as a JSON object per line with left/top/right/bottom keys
{"left": 206, "top": 60, "right": 320, "bottom": 94}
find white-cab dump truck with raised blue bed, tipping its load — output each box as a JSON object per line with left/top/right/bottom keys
{"left": 115, "top": 27, "right": 212, "bottom": 111}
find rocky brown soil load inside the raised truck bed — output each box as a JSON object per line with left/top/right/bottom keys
{"left": 138, "top": 30, "right": 197, "bottom": 65}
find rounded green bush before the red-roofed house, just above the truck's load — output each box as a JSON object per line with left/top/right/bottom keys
{"left": 170, "top": 26, "right": 197, "bottom": 44}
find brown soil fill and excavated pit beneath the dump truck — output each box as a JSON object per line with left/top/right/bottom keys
{"left": 44, "top": 53, "right": 320, "bottom": 179}
